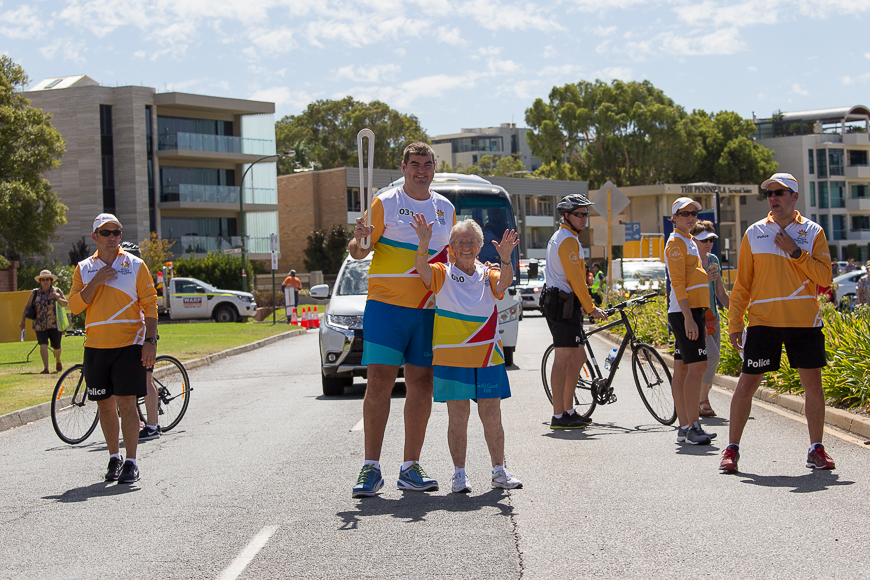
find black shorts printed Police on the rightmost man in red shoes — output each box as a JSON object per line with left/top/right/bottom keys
{"left": 741, "top": 326, "right": 827, "bottom": 375}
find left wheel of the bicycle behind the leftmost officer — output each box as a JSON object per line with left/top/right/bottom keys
{"left": 51, "top": 365, "right": 100, "bottom": 445}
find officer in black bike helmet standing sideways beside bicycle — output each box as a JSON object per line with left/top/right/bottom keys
{"left": 541, "top": 193, "right": 606, "bottom": 429}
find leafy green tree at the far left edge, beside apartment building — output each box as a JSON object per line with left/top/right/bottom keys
{"left": 0, "top": 55, "right": 67, "bottom": 259}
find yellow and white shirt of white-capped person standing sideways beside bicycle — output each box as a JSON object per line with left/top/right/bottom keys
{"left": 665, "top": 227, "right": 710, "bottom": 313}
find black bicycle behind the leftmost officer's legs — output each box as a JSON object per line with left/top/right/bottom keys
{"left": 51, "top": 354, "right": 193, "bottom": 445}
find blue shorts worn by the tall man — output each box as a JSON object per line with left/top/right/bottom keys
{"left": 362, "top": 300, "right": 435, "bottom": 367}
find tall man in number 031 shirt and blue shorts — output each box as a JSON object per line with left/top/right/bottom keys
{"left": 348, "top": 142, "right": 456, "bottom": 497}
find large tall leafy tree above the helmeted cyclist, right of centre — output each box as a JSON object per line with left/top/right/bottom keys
{"left": 526, "top": 80, "right": 697, "bottom": 188}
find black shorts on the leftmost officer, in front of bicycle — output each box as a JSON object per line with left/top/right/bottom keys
{"left": 84, "top": 344, "right": 147, "bottom": 401}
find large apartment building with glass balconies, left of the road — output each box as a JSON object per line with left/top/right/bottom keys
{"left": 23, "top": 75, "right": 279, "bottom": 261}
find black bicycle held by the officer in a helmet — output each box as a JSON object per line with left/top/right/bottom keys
{"left": 541, "top": 294, "right": 677, "bottom": 425}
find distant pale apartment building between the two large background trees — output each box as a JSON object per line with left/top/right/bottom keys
{"left": 432, "top": 123, "right": 541, "bottom": 171}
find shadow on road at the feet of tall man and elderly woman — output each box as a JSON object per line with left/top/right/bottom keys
{"left": 335, "top": 489, "right": 514, "bottom": 530}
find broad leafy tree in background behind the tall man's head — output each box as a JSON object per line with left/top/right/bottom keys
{"left": 275, "top": 96, "right": 429, "bottom": 172}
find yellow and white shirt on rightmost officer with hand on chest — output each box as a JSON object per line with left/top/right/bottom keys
{"left": 728, "top": 212, "right": 833, "bottom": 333}
